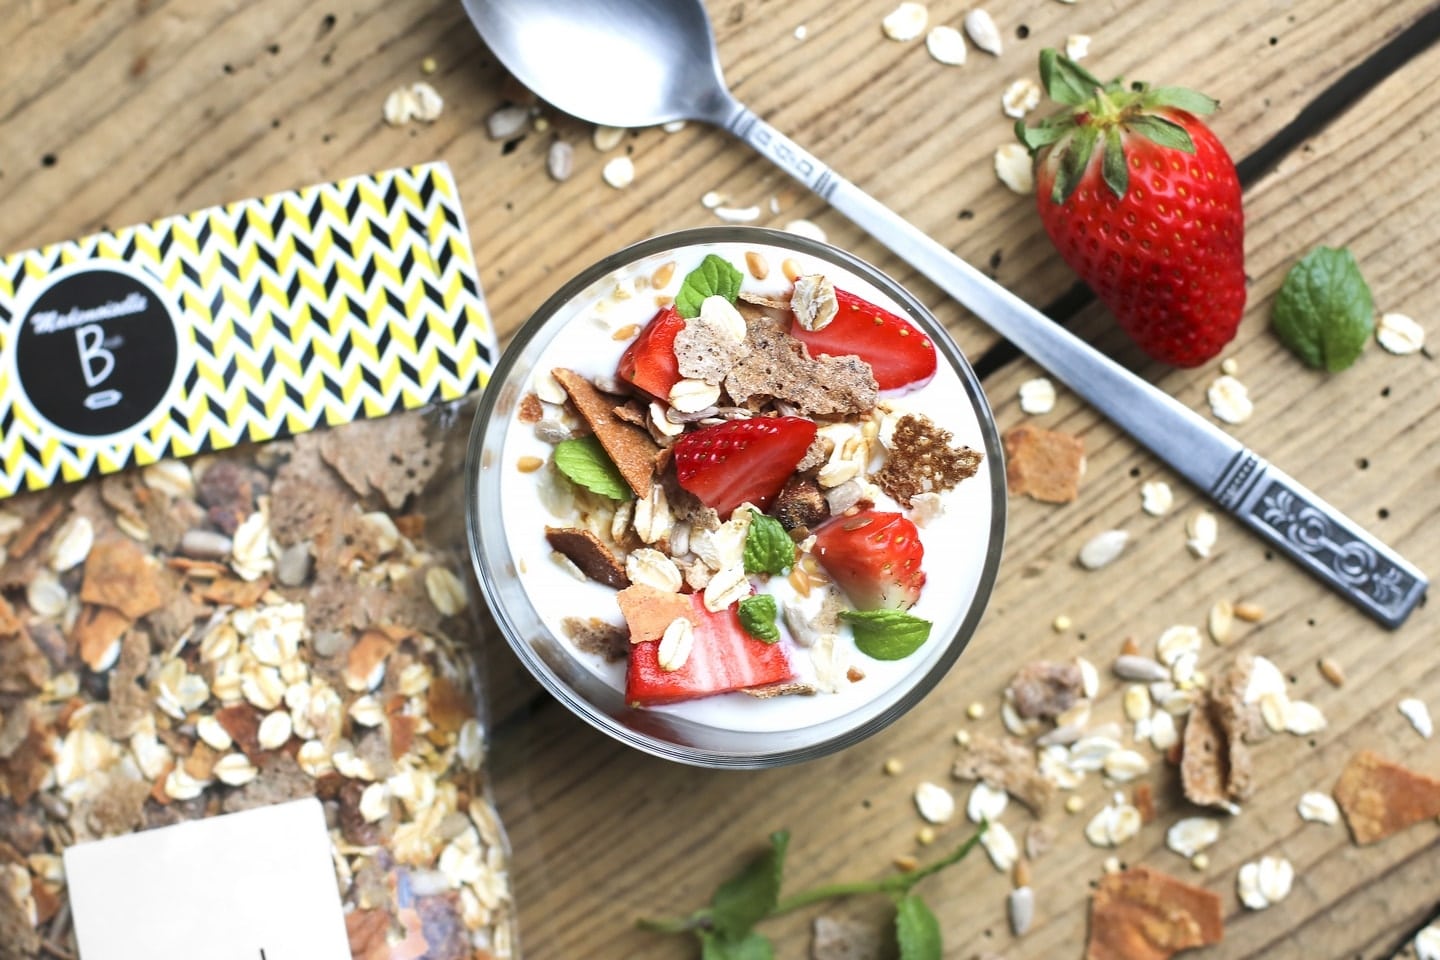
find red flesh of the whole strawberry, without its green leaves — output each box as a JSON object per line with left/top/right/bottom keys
{"left": 1035, "top": 109, "right": 1246, "bottom": 367}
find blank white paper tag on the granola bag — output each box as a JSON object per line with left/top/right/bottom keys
{"left": 65, "top": 799, "right": 350, "bottom": 960}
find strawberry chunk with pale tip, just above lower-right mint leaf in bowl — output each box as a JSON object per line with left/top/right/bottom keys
{"left": 815, "top": 510, "right": 924, "bottom": 610}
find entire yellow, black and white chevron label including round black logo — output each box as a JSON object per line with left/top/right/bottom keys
{"left": 0, "top": 164, "right": 495, "bottom": 497}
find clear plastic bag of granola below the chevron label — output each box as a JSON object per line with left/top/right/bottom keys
{"left": 0, "top": 397, "right": 518, "bottom": 960}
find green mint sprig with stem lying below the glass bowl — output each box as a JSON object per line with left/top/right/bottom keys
{"left": 636, "top": 822, "right": 988, "bottom": 960}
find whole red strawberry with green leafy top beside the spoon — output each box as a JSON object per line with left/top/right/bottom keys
{"left": 1015, "top": 50, "right": 1246, "bottom": 367}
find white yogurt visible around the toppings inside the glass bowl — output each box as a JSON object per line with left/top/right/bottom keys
{"left": 500, "top": 243, "right": 992, "bottom": 731}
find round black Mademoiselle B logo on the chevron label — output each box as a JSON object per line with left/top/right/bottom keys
{"left": 16, "top": 265, "right": 180, "bottom": 438}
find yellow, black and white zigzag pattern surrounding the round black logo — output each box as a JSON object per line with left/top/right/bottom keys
{"left": 0, "top": 164, "right": 497, "bottom": 497}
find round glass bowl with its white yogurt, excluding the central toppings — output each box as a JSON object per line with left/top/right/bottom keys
{"left": 465, "top": 226, "right": 1005, "bottom": 769}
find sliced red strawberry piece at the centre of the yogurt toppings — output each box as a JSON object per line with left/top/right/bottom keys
{"left": 674, "top": 417, "right": 815, "bottom": 517}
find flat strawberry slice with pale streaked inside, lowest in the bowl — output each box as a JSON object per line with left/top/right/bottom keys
{"left": 625, "top": 593, "right": 795, "bottom": 707}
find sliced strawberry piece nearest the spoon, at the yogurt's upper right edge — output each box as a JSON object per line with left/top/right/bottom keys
{"left": 791, "top": 289, "right": 935, "bottom": 390}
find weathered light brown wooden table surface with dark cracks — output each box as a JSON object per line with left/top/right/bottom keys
{"left": 0, "top": 0, "right": 1440, "bottom": 960}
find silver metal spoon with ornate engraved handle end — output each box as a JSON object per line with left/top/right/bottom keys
{"left": 464, "top": 0, "right": 1427, "bottom": 628}
